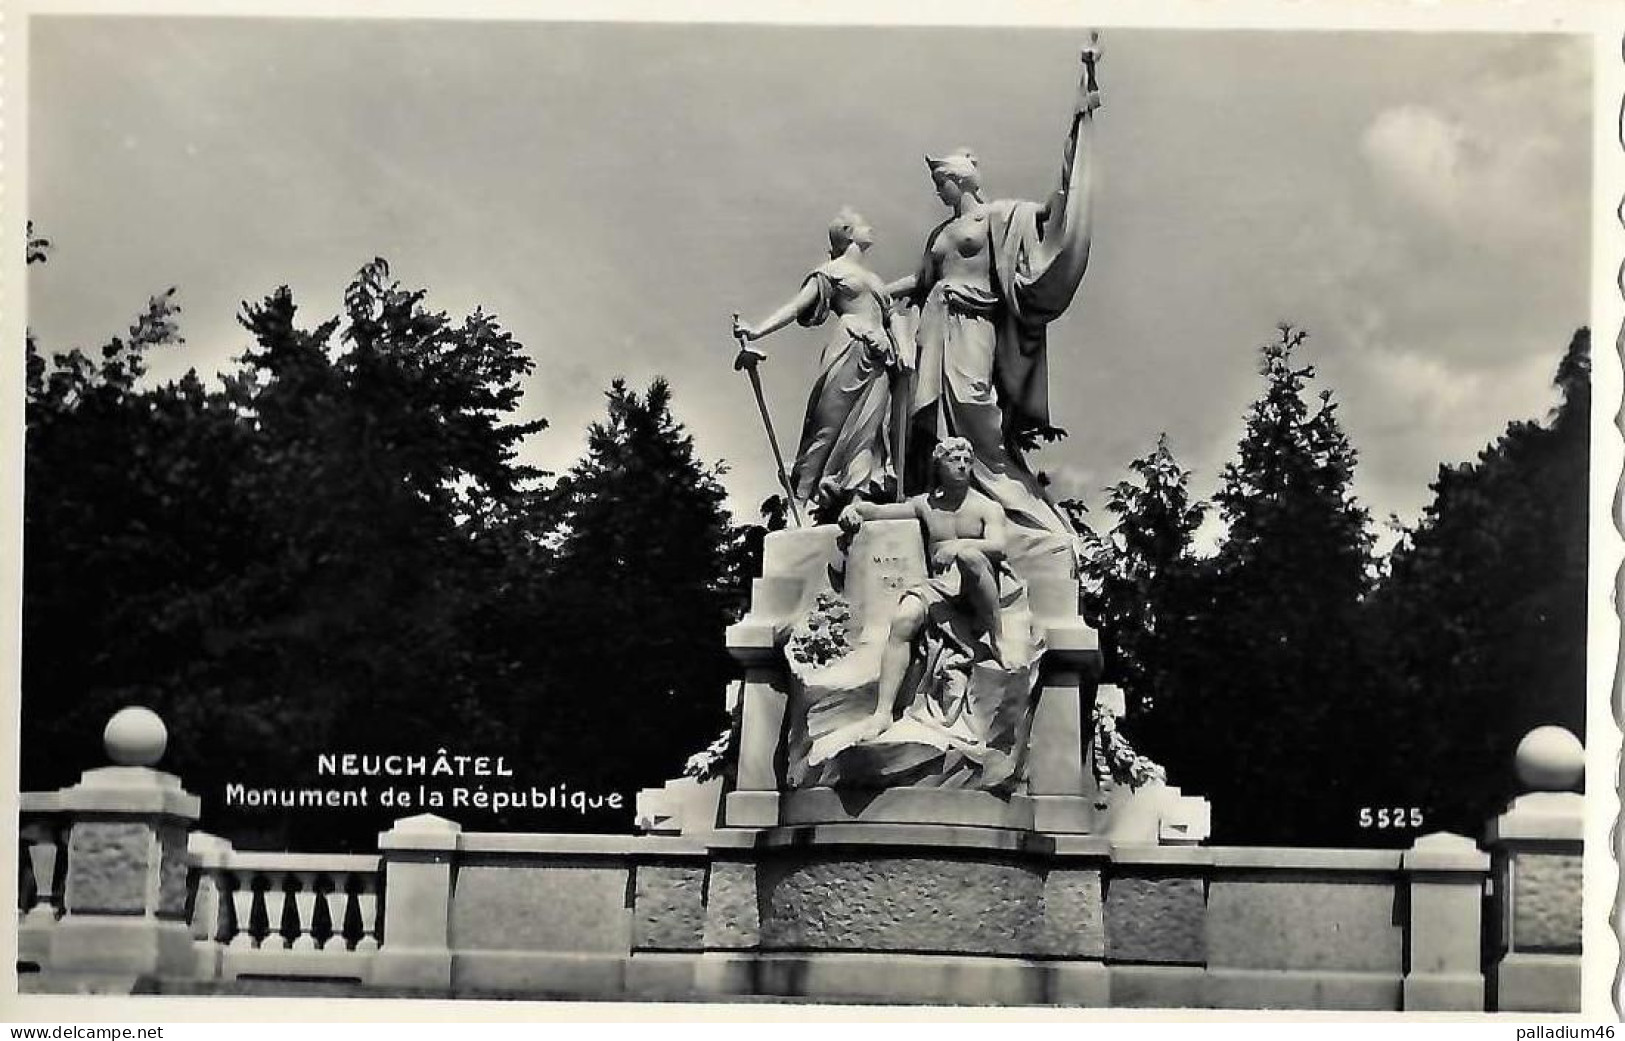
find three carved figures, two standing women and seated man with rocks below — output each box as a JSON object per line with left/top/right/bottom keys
{"left": 733, "top": 37, "right": 1100, "bottom": 791}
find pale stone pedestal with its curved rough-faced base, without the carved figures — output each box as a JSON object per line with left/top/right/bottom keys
{"left": 634, "top": 521, "right": 1207, "bottom": 1005}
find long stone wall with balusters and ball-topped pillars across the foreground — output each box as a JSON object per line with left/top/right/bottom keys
{"left": 18, "top": 713, "right": 1583, "bottom": 1012}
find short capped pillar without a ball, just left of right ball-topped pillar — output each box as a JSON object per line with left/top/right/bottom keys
{"left": 1401, "top": 832, "right": 1490, "bottom": 1012}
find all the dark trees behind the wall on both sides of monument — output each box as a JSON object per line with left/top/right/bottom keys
{"left": 21, "top": 220, "right": 1591, "bottom": 848}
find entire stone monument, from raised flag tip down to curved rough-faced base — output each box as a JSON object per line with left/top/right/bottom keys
{"left": 639, "top": 41, "right": 1209, "bottom": 1004}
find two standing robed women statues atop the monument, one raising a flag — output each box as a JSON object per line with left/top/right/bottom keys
{"left": 733, "top": 42, "right": 1100, "bottom": 536}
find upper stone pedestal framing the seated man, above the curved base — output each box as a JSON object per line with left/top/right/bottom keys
{"left": 705, "top": 520, "right": 1209, "bottom": 844}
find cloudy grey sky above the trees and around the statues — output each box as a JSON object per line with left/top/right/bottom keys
{"left": 28, "top": 16, "right": 1591, "bottom": 548}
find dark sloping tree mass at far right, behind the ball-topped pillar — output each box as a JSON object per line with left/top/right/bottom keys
{"left": 1373, "top": 330, "right": 1591, "bottom": 832}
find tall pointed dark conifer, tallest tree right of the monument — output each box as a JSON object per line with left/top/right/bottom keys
{"left": 1165, "top": 326, "right": 1381, "bottom": 844}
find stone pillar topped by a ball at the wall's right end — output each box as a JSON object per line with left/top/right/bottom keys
{"left": 1487, "top": 726, "right": 1584, "bottom": 1012}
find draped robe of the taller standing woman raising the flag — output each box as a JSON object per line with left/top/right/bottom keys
{"left": 908, "top": 200, "right": 1082, "bottom": 538}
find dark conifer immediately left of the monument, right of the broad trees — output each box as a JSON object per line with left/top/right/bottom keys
{"left": 541, "top": 378, "right": 738, "bottom": 783}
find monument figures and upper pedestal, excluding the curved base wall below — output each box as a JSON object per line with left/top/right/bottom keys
{"left": 708, "top": 36, "right": 1207, "bottom": 843}
